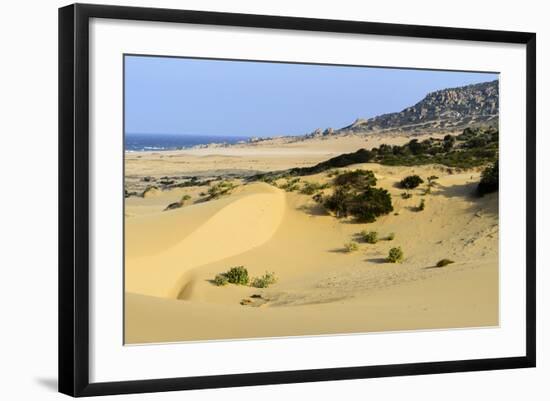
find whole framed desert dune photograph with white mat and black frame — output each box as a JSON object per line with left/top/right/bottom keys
{"left": 59, "top": 4, "right": 536, "bottom": 396}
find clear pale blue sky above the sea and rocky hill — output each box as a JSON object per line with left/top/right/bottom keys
{"left": 125, "top": 56, "right": 498, "bottom": 136}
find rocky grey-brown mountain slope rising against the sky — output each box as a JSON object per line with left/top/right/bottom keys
{"left": 307, "top": 80, "right": 499, "bottom": 137}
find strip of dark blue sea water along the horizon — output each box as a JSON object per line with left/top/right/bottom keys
{"left": 124, "top": 133, "right": 249, "bottom": 152}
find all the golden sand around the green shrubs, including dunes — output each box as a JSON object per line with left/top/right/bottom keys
{"left": 125, "top": 136, "right": 499, "bottom": 343}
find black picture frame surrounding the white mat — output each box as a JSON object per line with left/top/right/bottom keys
{"left": 59, "top": 4, "right": 536, "bottom": 396}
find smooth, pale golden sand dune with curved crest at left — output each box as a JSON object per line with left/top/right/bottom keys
{"left": 125, "top": 183, "right": 286, "bottom": 298}
